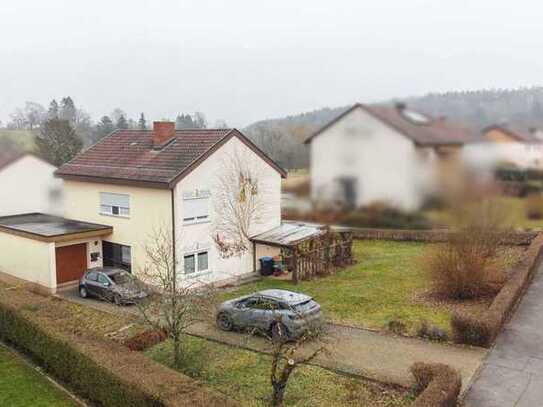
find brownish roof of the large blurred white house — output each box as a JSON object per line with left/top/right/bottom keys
{"left": 305, "top": 103, "right": 476, "bottom": 146}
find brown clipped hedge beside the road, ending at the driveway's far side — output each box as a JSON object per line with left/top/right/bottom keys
{"left": 451, "top": 234, "right": 543, "bottom": 347}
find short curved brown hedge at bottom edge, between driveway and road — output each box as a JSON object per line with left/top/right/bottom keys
{"left": 411, "top": 363, "right": 462, "bottom": 407}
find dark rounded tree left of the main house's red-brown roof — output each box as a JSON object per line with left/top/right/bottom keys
{"left": 36, "top": 119, "right": 83, "bottom": 167}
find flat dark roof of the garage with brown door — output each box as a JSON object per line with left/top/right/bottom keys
{"left": 0, "top": 213, "right": 113, "bottom": 242}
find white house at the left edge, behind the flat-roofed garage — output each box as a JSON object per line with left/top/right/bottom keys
{"left": 0, "top": 152, "right": 63, "bottom": 216}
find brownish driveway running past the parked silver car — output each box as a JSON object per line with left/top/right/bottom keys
{"left": 61, "top": 291, "right": 487, "bottom": 388}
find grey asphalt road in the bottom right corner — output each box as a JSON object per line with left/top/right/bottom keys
{"left": 465, "top": 265, "right": 543, "bottom": 407}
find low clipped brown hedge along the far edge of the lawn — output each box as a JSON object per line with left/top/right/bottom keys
{"left": 353, "top": 228, "right": 537, "bottom": 246}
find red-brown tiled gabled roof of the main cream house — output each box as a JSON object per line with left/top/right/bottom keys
{"left": 56, "top": 129, "right": 286, "bottom": 188}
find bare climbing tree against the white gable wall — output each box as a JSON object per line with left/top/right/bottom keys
{"left": 213, "top": 149, "right": 267, "bottom": 258}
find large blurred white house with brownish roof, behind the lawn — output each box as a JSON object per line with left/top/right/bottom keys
{"left": 306, "top": 104, "right": 474, "bottom": 209}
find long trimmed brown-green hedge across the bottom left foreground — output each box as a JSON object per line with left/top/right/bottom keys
{"left": 0, "top": 290, "right": 238, "bottom": 407}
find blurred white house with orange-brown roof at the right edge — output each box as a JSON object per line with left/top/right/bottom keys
{"left": 465, "top": 124, "right": 543, "bottom": 169}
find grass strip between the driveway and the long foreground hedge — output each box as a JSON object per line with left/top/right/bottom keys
{"left": 147, "top": 337, "right": 411, "bottom": 407}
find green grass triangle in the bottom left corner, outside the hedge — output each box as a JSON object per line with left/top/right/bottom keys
{"left": 0, "top": 345, "right": 77, "bottom": 407}
